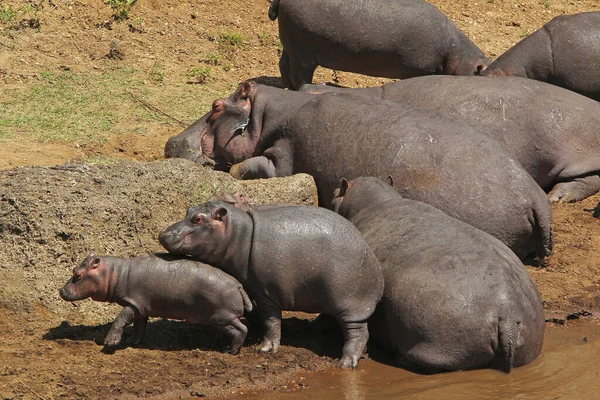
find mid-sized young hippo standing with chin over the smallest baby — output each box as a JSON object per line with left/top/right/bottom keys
{"left": 159, "top": 200, "right": 383, "bottom": 368}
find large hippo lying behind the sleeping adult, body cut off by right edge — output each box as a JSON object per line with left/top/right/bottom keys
{"left": 300, "top": 76, "right": 600, "bottom": 201}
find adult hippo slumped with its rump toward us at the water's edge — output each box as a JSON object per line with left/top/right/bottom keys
{"left": 333, "top": 178, "right": 544, "bottom": 372}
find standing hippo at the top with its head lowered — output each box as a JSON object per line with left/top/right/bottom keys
{"left": 269, "top": 0, "right": 491, "bottom": 89}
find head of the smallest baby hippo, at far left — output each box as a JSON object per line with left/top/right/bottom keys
{"left": 59, "top": 253, "right": 108, "bottom": 301}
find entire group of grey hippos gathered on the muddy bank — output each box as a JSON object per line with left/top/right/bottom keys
{"left": 60, "top": 0, "right": 600, "bottom": 373}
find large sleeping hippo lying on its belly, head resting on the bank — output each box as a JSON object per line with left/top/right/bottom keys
{"left": 169, "top": 82, "right": 552, "bottom": 258}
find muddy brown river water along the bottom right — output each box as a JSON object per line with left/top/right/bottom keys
{"left": 245, "top": 320, "right": 600, "bottom": 400}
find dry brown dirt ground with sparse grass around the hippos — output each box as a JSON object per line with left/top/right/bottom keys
{"left": 0, "top": 0, "right": 600, "bottom": 398}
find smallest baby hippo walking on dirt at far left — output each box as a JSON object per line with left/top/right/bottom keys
{"left": 60, "top": 253, "right": 252, "bottom": 354}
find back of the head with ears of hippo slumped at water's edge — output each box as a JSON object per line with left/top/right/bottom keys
{"left": 331, "top": 176, "right": 400, "bottom": 219}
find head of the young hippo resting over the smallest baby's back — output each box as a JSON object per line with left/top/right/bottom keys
{"left": 159, "top": 200, "right": 232, "bottom": 264}
